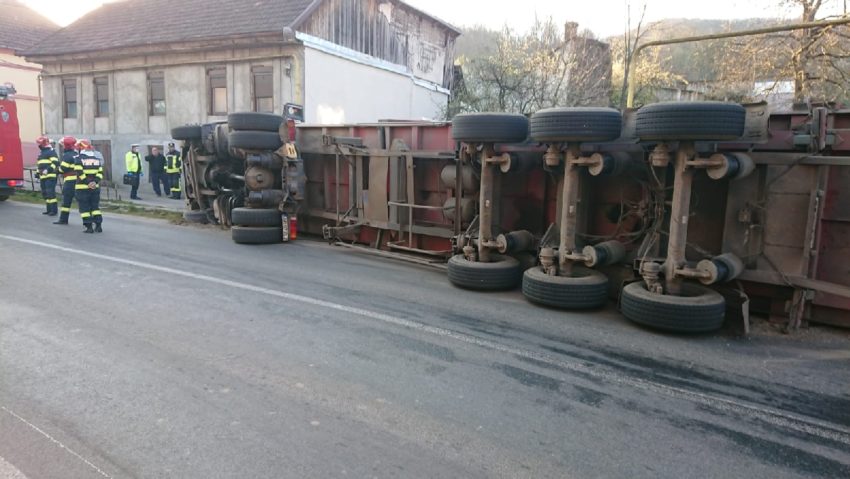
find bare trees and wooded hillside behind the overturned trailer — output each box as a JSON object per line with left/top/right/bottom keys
{"left": 446, "top": 0, "right": 850, "bottom": 114}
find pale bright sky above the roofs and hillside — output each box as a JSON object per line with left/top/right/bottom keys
{"left": 22, "top": 0, "right": 850, "bottom": 38}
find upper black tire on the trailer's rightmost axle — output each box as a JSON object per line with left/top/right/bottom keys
{"left": 635, "top": 101, "right": 747, "bottom": 141}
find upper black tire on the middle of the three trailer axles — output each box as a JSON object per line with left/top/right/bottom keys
{"left": 530, "top": 107, "right": 623, "bottom": 143}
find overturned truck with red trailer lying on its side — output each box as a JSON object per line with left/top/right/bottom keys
{"left": 172, "top": 102, "right": 850, "bottom": 333}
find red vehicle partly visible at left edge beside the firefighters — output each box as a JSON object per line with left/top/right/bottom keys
{"left": 0, "top": 84, "right": 24, "bottom": 201}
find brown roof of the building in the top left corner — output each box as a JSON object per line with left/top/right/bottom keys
{"left": 0, "top": 0, "right": 59, "bottom": 51}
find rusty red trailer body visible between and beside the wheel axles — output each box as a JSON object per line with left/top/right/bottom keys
{"left": 297, "top": 109, "right": 850, "bottom": 326}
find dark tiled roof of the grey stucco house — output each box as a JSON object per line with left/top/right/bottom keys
{"left": 26, "top": 0, "right": 456, "bottom": 56}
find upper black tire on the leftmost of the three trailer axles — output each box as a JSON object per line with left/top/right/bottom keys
{"left": 452, "top": 113, "right": 528, "bottom": 143}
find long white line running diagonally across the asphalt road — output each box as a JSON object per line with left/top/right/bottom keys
{"left": 0, "top": 234, "right": 850, "bottom": 446}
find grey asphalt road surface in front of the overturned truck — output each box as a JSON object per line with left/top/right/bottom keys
{"left": 0, "top": 202, "right": 850, "bottom": 479}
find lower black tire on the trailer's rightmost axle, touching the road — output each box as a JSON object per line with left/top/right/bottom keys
{"left": 620, "top": 281, "right": 726, "bottom": 333}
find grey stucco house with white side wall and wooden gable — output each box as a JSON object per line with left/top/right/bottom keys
{"left": 25, "top": 0, "right": 460, "bottom": 184}
